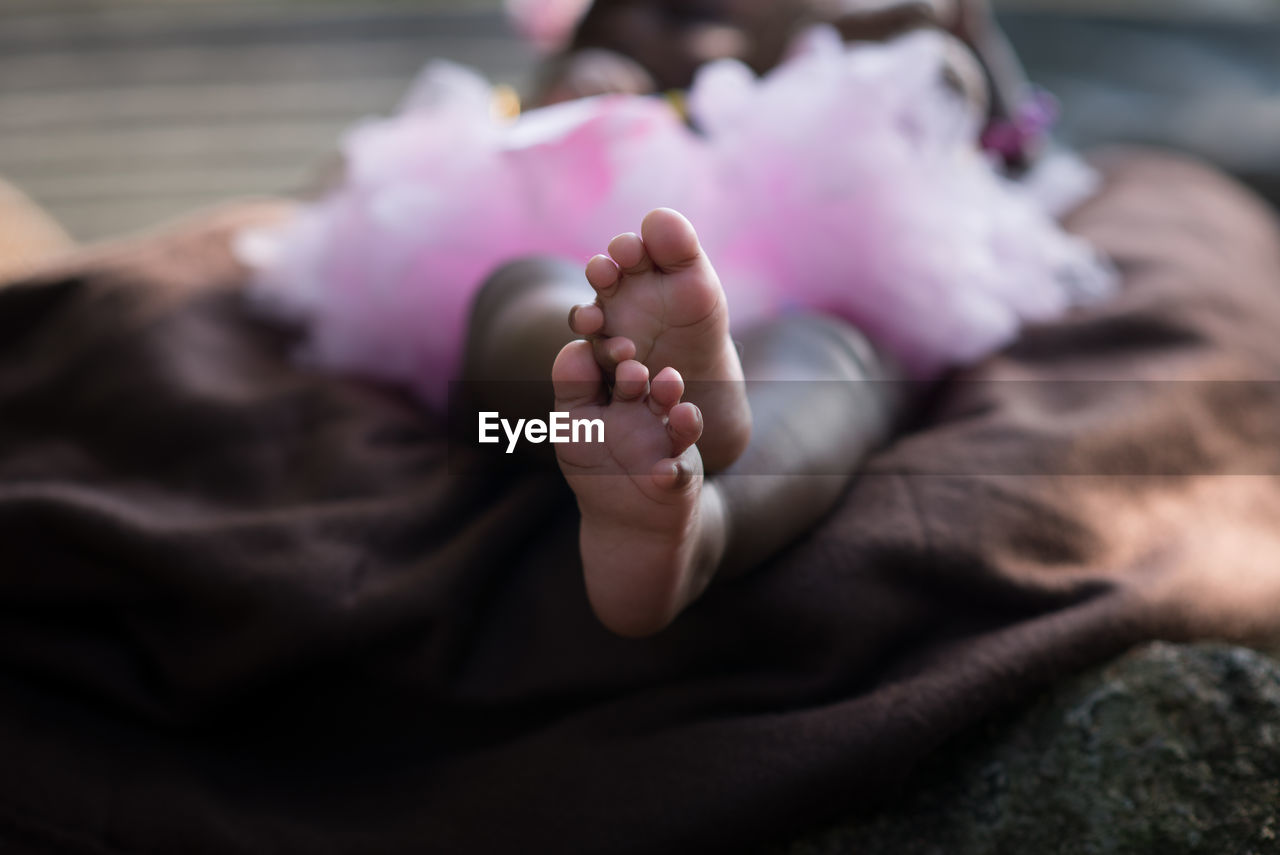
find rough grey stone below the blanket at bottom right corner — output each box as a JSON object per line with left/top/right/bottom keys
{"left": 787, "top": 644, "right": 1280, "bottom": 855}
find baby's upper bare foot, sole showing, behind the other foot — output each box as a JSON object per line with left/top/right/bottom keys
{"left": 570, "top": 209, "right": 751, "bottom": 471}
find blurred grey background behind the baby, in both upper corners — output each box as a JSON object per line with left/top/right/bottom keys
{"left": 0, "top": 0, "right": 1280, "bottom": 241}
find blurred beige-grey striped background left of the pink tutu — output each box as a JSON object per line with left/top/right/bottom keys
{"left": 0, "top": 0, "right": 532, "bottom": 239}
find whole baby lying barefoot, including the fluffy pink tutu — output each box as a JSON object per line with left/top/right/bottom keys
{"left": 246, "top": 0, "right": 1090, "bottom": 636}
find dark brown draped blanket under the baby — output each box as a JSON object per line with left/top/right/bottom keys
{"left": 0, "top": 155, "right": 1280, "bottom": 855}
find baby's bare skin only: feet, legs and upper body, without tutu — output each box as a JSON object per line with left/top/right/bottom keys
{"left": 466, "top": 0, "right": 1049, "bottom": 636}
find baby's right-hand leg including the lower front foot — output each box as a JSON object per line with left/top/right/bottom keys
{"left": 556, "top": 316, "right": 905, "bottom": 636}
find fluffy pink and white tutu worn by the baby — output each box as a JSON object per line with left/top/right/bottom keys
{"left": 241, "top": 29, "right": 1112, "bottom": 404}
